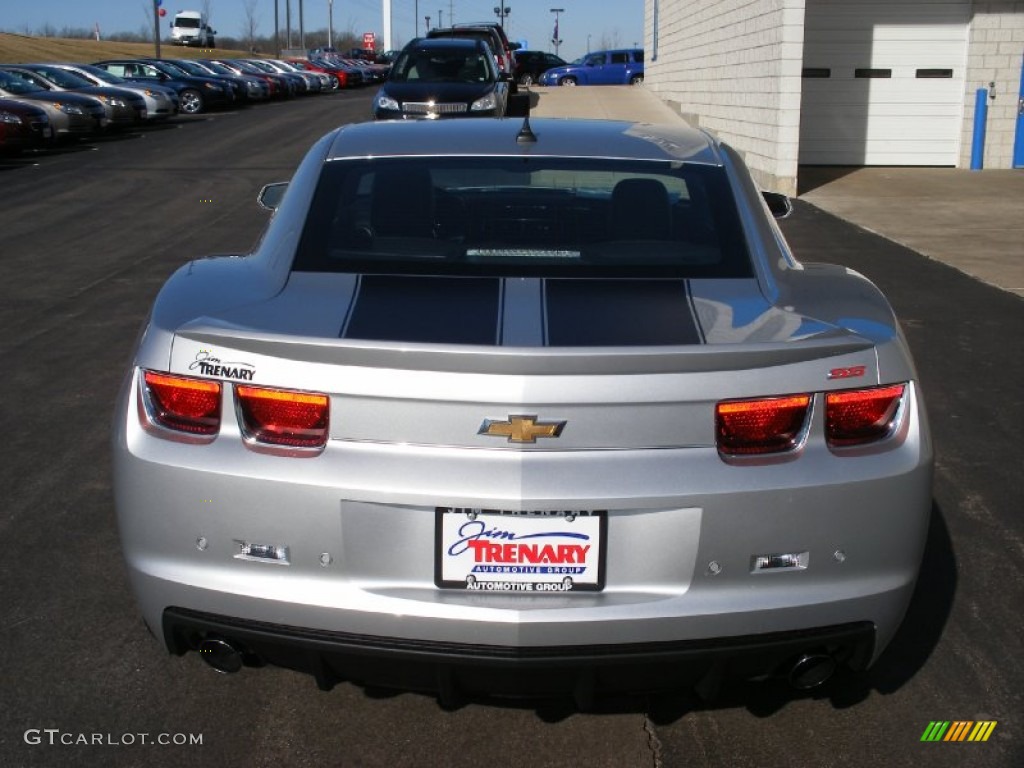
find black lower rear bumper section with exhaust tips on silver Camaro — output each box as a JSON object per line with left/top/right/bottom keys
{"left": 162, "top": 607, "right": 874, "bottom": 696}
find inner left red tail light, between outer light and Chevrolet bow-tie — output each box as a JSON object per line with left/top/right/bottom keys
{"left": 234, "top": 384, "right": 330, "bottom": 449}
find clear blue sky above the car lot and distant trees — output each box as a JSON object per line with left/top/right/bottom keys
{"left": 0, "top": 0, "right": 643, "bottom": 59}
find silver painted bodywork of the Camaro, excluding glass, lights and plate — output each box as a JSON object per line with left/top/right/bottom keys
{"left": 114, "top": 120, "right": 932, "bottom": 684}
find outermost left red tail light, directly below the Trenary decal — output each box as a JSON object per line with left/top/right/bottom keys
{"left": 142, "top": 371, "right": 220, "bottom": 435}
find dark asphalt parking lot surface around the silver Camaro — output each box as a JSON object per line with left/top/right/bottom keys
{"left": 0, "top": 89, "right": 1024, "bottom": 768}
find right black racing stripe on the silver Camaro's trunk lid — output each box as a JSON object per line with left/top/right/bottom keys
{"left": 545, "top": 279, "right": 700, "bottom": 346}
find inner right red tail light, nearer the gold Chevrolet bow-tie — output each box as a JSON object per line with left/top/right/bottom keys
{"left": 715, "top": 394, "right": 811, "bottom": 456}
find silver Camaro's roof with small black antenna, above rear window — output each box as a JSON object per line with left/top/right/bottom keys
{"left": 327, "top": 118, "right": 722, "bottom": 165}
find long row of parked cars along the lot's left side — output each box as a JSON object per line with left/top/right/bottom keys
{"left": 0, "top": 53, "right": 388, "bottom": 152}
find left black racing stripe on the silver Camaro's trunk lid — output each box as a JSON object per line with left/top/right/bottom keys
{"left": 344, "top": 274, "right": 501, "bottom": 344}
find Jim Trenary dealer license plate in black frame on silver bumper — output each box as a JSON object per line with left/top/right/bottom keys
{"left": 434, "top": 507, "right": 607, "bottom": 594}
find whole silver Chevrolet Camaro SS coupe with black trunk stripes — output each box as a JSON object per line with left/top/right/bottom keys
{"left": 114, "top": 119, "right": 933, "bottom": 700}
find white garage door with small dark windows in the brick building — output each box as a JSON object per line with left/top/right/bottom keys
{"left": 800, "top": 0, "right": 970, "bottom": 166}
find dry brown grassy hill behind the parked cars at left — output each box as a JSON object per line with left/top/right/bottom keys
{"left": 0, "top": 32, "right": 251, "bottom": 63}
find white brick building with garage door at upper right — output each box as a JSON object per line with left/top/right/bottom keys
{"left": 644, "top": 0, "right": 1024, "bottom": 194}
